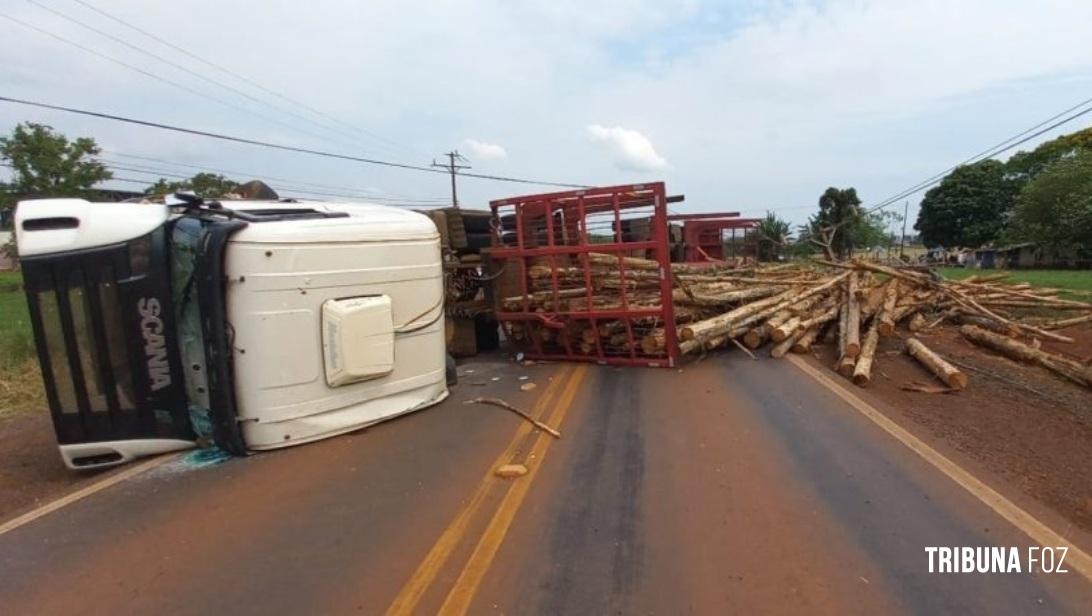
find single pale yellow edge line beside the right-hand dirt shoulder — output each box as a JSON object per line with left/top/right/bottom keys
{"left": 786, "top": 355, "right": 1092, "bottom": 581}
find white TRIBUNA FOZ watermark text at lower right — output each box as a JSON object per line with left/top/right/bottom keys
{"left": 925, "top": 545, "right": 1069, "bottom": 573}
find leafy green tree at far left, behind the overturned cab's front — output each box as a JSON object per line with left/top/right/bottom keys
{"left": 0, "top": 122, "right": 114, "bottom": 261}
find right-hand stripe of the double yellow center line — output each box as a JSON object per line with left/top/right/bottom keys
{"left": 440, "top": 365, "right": 587, "bottom": 616}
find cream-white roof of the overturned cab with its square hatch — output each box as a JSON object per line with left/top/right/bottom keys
{"left": 225, "top": 202, "right": 448, "bottom": 449}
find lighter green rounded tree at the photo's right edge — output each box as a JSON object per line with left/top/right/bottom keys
{"left": 1009, "top": 150, "right": 1092, "bottom": 248}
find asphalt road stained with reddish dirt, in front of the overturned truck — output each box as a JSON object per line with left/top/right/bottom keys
{"left": 0, "top": 354, "right": 1092, "bottom": 615}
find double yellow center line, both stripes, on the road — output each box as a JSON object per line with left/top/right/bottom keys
{"left": 387, "top": 365, "right": 587, "bottom": 616}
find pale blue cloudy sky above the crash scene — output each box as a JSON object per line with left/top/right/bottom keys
{"left": 0, "top": 0, "right": 1092, "bottom": 231}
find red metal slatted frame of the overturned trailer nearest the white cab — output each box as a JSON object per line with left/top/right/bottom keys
{"left": 489, "top": 182, "right": 678, "bottom": 367}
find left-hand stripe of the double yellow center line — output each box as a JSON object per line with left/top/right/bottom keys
{"left": 387, "top": 366, "right": 574, "bottom": 616}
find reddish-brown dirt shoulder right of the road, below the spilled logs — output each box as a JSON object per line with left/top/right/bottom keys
{"left": 810, "top": 327, "right": 1092, "bottom": 531}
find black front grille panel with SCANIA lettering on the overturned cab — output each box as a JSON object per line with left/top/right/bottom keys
{"left": 22, "top": 225, "right": 195, "bottom": 467}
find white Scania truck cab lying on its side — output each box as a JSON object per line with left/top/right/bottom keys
{"left": 15, "top": 196, "right": 448, "bottom": 469}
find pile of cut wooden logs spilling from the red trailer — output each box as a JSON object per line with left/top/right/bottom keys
{"left": 502, "top": 253, "right": 1092, "bottom": 391}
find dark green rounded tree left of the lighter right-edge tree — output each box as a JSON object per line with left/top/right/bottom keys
{"left": 914, "top": 159, "right": 1019, "bottom": 248}
